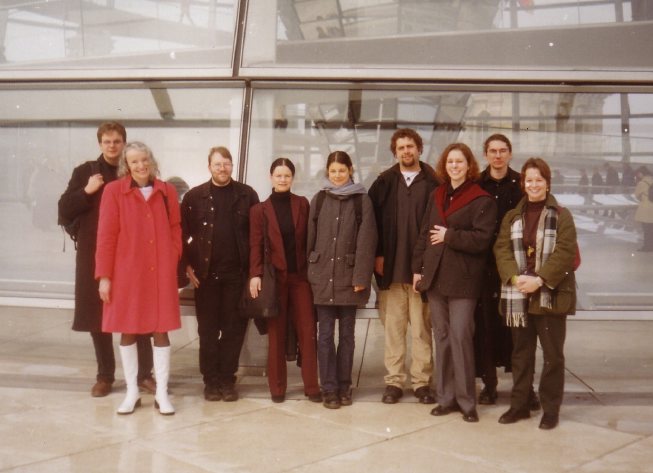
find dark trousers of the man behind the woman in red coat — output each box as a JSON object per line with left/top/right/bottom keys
{"left": 91, "top": 332, "right": 154, "bottom": 383}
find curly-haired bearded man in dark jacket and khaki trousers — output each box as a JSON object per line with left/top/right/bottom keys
{"left": 369, "top": 128, "right": 437, "bottom": 404}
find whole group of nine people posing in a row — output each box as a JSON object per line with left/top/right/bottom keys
{"left": 59, "top": 122, "right": 577, "bottom": 429}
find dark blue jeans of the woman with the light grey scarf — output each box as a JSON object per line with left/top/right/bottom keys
{"left": 316, "top": 305, "right": 356, "bottom": 393}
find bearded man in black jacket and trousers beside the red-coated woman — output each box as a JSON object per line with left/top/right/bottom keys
{"left": 181, "top": 146, "right": 259, "bottom": 402}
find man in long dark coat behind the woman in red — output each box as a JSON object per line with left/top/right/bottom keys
{"left": 59, "top": 122, "right": 156, "bottom": 397}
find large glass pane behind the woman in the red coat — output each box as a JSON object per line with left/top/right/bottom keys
{"left": 0, "top": 83, "right": 243, "bottom": 298}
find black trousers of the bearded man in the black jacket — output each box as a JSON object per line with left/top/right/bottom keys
{"left": 195, "top": 277, "right": 248, "bottom": 386}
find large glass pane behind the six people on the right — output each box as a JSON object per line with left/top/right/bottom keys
{"left": 247, "top": 88, "right": 653, "bottom": 310}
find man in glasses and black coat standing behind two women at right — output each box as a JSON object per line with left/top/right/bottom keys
{"left": 474, "top": 133, "right": 540, "bottom": 410}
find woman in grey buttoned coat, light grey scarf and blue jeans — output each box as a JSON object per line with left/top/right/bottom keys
{"left": 307, "top": 151, "right": 377, "bottom": 409}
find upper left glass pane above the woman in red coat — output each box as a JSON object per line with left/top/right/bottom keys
{"left": 0, "top": 0, "right": 237, "bottom": 70}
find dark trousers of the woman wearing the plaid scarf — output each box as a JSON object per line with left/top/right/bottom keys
{"left": 510, "top": 314, "right": 567, "bottom": 414}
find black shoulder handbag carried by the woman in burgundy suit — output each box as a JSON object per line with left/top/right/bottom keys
{"left": 240, "top": 214, "right": 279, "bottom": 319}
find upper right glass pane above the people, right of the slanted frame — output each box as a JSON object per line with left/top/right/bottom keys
{"left": 242, "top": 0, "right": 653, "bottom": 78}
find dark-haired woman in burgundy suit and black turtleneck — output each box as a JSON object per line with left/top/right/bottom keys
{"left": 249, "top": 158, "right": 322, "bottom": 402}
